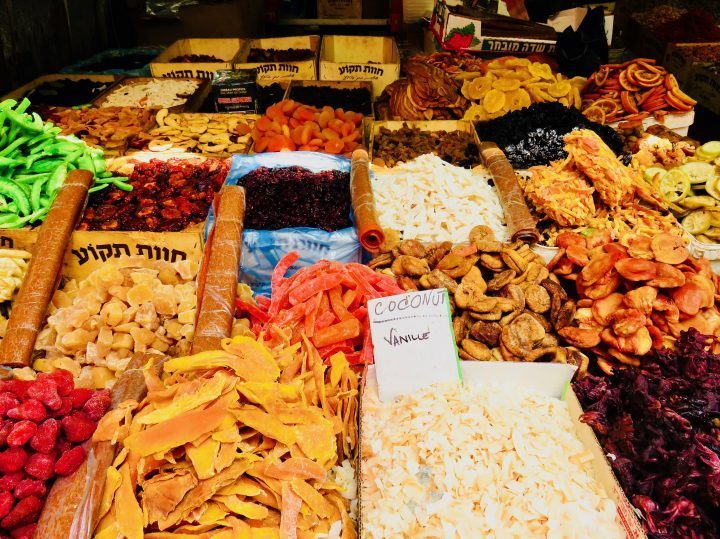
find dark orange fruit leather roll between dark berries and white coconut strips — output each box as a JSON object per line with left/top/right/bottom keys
{"left": 350, "top": 150, "right": 385, "bottom": 253}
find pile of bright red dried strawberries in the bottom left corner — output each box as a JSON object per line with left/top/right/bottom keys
{"left": 0, "top": 370, "right": 110, "bottom": 539}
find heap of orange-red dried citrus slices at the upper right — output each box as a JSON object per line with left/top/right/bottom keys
{"left": 582, "top": 58, "right": 697, "bottom": 124}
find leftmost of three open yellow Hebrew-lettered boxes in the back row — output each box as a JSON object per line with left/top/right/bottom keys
{"left": 150, "top": 38, "right": 247, "bottom": 79}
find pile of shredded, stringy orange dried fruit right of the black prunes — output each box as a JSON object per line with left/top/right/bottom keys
{"left": 521, "top": 129, "right": 681, "bottom": 245}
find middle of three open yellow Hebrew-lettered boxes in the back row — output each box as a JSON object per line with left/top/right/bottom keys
{"left": 233, "top": 36, "right": 320, "bottom": 82}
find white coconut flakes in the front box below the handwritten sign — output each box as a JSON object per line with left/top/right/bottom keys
{"left": 361, "top": 385, "right": 625, "bottom": 539}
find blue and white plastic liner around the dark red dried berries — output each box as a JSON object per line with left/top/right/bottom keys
{"left": 205, "top": 152, "right": 362, "bottom": 296}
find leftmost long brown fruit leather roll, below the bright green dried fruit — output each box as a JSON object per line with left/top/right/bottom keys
{"left": 0, "top": 170, "right": 93, "bottom": 367}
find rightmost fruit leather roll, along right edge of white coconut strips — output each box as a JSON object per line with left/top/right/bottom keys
{"left": 480, "top": 142, "right": 540, "bottom": 243}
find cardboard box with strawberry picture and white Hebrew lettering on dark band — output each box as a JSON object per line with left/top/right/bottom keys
{"left": 430, "top": 0, "right": 557, "bottom": 56}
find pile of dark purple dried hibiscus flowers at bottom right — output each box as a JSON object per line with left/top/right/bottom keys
{"left": 575, "top": 329, "right": 720, "bottom": 539}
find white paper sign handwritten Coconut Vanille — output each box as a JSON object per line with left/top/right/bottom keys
{"left": 368, "top": 288, "right": 462, "bottom": 401}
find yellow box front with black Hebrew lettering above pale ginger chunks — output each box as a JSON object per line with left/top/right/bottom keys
{"left": 63, "top": 229, "right": 203, "bottom": 279}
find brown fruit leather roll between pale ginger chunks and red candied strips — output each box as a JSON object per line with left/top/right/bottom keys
{"left": 192, "top": 185, "right": 245, "bottom": 354}
